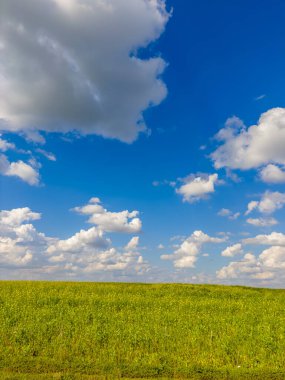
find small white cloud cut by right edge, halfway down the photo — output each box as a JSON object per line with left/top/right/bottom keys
{"left": 245, "top": 191, "right": 285, "bottom": 215}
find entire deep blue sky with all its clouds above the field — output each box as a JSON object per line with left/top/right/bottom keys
{"left": 0, "top": 0, "right": 285, "bottom": 288}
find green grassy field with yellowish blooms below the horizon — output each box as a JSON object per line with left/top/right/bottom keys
{"left": 0, "top": 282, "right": 285, "bottom": 380}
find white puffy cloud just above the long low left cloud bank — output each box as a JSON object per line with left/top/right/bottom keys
{"left": 73, "top": 198, "right": 142, "bottom": 233}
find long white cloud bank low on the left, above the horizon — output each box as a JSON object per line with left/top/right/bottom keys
{"left": 0, "top": 207, "right": 149, "bottom": 278}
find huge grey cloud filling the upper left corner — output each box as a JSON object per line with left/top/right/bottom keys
{"left": 0, "top": 0, "right": 170, "bottom": 143}
